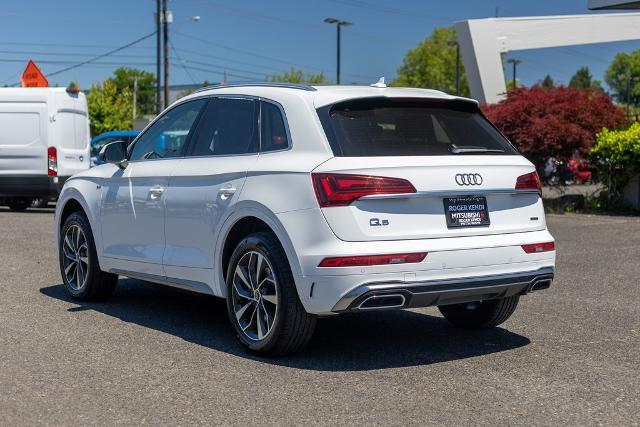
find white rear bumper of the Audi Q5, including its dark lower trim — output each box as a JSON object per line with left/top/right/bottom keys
{"left": 278, "top": 209, "right": 556, "bottom": 315}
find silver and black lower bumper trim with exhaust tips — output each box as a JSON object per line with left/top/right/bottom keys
{"left": 331, "top": 267, "right": 554, "bottom": 313}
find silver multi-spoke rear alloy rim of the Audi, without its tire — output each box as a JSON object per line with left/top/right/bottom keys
{"left": 232, "top": 251, "right": 278, "bottom": 341}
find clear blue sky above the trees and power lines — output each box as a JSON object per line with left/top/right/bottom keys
{"left": 0, "top": 0, "right": 640, "bottom": 88}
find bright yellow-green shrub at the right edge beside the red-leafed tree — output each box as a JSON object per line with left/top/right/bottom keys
{"left": 591, "top": 122, "right": 640, "bottom": 202}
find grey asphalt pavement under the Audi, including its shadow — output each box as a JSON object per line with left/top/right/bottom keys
{"left": 0, "top": 208, "right": 640, "bottom": 426}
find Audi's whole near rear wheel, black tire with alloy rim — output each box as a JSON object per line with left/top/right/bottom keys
{"left": 226, "top": 232, "right": 317, "bottom": 356}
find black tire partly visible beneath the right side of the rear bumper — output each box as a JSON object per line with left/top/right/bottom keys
{"left": 438, "top": 295, "right": 520, "bottom": 329}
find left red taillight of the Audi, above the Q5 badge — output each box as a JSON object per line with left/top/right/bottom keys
{"left": 311, "top": 173, "right": 416, "bottom": 208}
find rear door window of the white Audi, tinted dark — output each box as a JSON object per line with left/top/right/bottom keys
{"left": 190, "top": 98, "right": 258, "bottom": 156}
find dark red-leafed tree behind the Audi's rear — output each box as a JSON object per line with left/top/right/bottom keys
{"left": 482, "top": 86, "right": 627, "bottom": 166}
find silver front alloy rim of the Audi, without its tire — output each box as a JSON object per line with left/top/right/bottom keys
{"left": 62, "top": 224, "right": 89, "bottom": 291}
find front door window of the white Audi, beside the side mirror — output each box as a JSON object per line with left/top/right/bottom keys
{"left": 129, "top": 99, "right": 206, "bottom": 160}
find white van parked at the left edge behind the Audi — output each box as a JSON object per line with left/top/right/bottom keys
{"left": 0, "top": 87, "right": 90, "bottom": 210}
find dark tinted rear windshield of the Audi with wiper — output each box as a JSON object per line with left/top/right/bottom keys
{"left": 318, "top": 98, "right": 518, "bottom": 157}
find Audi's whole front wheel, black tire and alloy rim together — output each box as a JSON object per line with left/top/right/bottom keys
{"left": 58, "top": 211, "right": 118, "bottom": 301}
